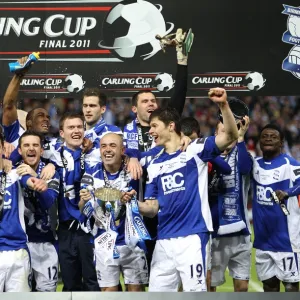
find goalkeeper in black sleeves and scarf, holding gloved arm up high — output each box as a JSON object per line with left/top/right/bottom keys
{"left": 124, "top": 29, "right": 188, "bottom": 266}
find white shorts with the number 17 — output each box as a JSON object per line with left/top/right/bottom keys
{"left": 256, "top": 249, "right": 300, "bottom": 282}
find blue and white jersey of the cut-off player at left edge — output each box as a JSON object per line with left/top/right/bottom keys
{"left": 0, "top": 169, "right": 30, "bottom": 251}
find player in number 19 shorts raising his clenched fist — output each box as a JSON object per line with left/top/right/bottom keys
{"left": 123, "top": 88, "right": 238, "bottom": 291}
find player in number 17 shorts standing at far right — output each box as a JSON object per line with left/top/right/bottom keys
{"left": 252, "top": 124, "right": 300, "bottom": 292}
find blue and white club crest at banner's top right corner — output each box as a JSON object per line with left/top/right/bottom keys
{"left": 282, "top": 4, "right": 300, "bottom": 79}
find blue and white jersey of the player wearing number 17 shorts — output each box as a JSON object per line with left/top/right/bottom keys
{"left": 252, "top": 154, "right": 300, "bottom": 252}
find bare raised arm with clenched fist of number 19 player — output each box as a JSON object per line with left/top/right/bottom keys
{"left": 208, "top": 88, "right": 238, "bottom": 151}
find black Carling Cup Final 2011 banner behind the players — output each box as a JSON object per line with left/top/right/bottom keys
{"left": 0, "top": 0, "right": 300, "bottom": 98}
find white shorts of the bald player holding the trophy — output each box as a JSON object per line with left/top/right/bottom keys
{"left": 95, "top": 245, "right": 148, "bottom": 288}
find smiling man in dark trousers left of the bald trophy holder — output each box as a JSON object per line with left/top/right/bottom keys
{"left": 49, "top": 113, "right": 100, "bottom": 291}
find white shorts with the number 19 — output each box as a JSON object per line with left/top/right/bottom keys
{"left": 149, "top": 234, "right": 209, "bottom": 292}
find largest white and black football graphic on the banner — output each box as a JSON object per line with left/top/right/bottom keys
{"left": 99, "top": 0, "right": 174, "bottom": 60}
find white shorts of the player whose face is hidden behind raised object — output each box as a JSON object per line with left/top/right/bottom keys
{"left": 211, "top": 235, "right": 252, "bottom": 286}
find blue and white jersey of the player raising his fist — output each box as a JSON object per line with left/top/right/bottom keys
{"left": 145, "top": 137, "right": 220, "bottom": 239}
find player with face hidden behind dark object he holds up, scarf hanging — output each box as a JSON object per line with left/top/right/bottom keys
{"left": 209, "top": 99, "right": 252, "bottom": 292}
